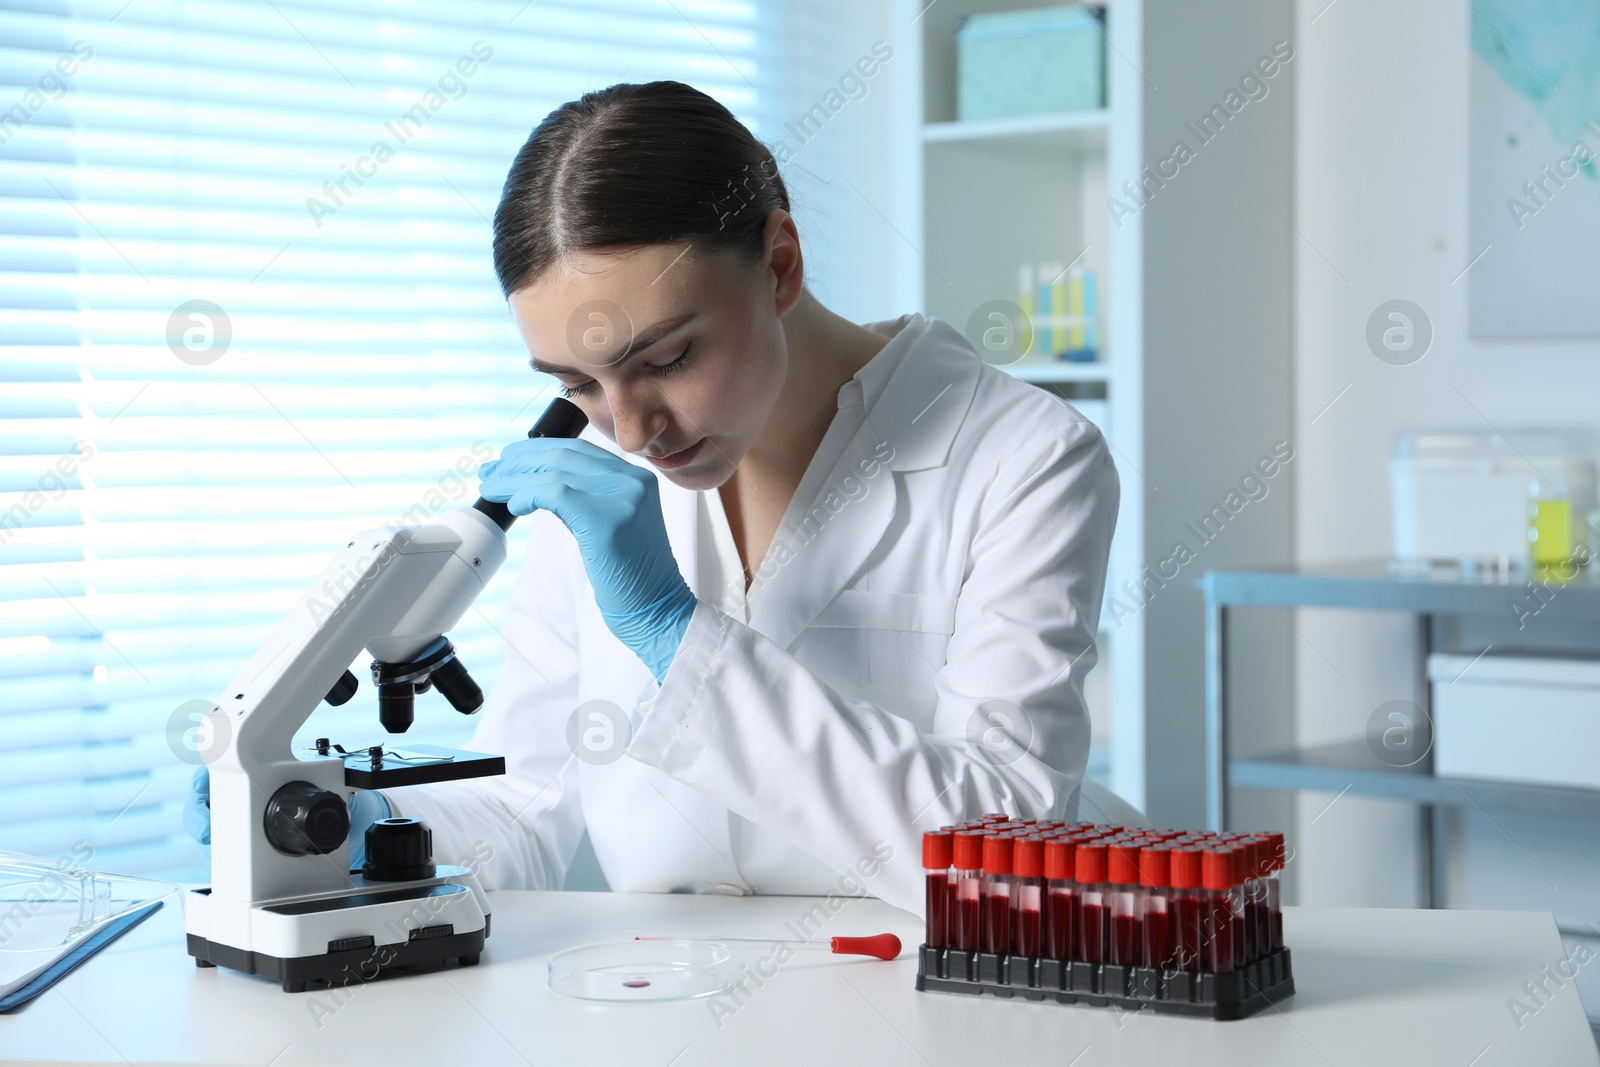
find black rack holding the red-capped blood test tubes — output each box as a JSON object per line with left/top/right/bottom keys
{"left": 917, "top": 945, "right": 1294, "bottom": 1019}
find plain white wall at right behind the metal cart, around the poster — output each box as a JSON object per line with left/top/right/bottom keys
{"left": 1294, "top": 0, "right": 1600, "bottom": 918}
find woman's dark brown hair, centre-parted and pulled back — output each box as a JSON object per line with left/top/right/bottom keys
{"left": 494, "top": 82, "right": 789, "bottom": 296}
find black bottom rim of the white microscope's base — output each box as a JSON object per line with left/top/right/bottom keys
{"left": 187, "top": 918, "right": 490, "bottom": 993}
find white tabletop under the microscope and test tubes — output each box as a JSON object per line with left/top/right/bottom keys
{"left": 0, "top": 893, "right": 1600, "bottom": 1067}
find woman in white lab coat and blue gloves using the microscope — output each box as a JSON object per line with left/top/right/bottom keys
{"left": 190, "top": 82, "right": 1120, "bottom": 912}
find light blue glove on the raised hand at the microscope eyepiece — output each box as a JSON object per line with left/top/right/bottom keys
{"left": 478, "top": 437, "right": 694, "bottom": 681}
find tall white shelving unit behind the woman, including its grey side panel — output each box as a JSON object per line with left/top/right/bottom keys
{"left": 894, "top": 0, "right": 1291, "bottom": 822}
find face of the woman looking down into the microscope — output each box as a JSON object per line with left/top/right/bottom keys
{"left": 510, "top": 245, "right": 790, "bottom": 490}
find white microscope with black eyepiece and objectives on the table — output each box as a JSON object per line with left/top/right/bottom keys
{"left": 184, "top": 398, "right": 587, "bottom": 993}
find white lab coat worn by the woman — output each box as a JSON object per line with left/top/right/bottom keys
{"left": 384, "top": 315, "right": 1120, "bottom": 913}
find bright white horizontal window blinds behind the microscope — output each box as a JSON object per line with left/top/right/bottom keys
{"left": 0, "top": 0, "right": 782, "bottom": 881}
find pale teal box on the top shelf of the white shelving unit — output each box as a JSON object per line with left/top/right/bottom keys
{"left": 955, "top": 5, "right": 1106, "bottom": 120}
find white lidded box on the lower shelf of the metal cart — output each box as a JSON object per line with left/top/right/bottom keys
{"left": 1427, "top": 653, "right": 1600, "bottom": 789}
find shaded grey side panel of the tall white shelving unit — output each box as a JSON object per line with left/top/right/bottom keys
{"left": 1139, "top": 0, "right": 1301, "bottom": 829}
